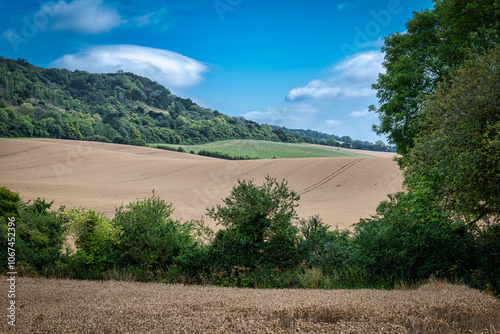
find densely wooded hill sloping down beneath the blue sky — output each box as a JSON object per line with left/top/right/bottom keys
{"left": 0, "top": 57, "right": 396, "bottom": 150}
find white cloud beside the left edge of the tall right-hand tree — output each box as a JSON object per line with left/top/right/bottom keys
{"left": 286, "top": 51, "right": 384, "bottom": 101}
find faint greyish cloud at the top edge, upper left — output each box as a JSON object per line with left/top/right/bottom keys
{"left": 35, "top": 0, "right": 126, "bottom": 34}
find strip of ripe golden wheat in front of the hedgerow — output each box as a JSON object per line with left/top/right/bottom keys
{"left": 0, "top": 278, "right": 500, "bottom": 333}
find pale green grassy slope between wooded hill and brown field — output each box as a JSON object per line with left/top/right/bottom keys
{"left": 150, "top": 140, "right": 374, "bottom": 159}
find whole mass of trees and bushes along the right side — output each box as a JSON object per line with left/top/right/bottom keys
{"left": 360, "top": 0, "right": 500, "bottom": 294}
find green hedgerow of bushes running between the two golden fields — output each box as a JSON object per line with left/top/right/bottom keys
{"left": 0, "top": 177, "right": 500, "bottom": 294}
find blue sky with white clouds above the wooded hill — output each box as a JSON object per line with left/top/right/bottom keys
{"left": 0, "top": 0, "right": 432, "bottom": 142}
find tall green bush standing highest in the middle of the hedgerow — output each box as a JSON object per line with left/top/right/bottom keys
{"left": 208, "top": 176, "right": 300, "bottom": 269}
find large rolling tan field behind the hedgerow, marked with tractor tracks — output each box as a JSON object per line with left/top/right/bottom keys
{"left": 0, "top": 139, "right": 402, "bottom": 228}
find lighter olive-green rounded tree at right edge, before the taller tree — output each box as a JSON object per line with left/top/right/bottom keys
{"left": 404, "top": 47, "right": 500, "bottom": 223}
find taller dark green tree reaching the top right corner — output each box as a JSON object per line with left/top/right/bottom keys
{"left": 370, "top": 0, "right": 500, "bottom": 155}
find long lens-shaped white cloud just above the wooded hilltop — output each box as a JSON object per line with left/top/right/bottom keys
{"left": 49, "top": 45, "right": 208, "bottom": 88}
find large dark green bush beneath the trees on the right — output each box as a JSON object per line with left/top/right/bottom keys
{"left": 353, "top": 188, "right": 473, "bottom": 284}
